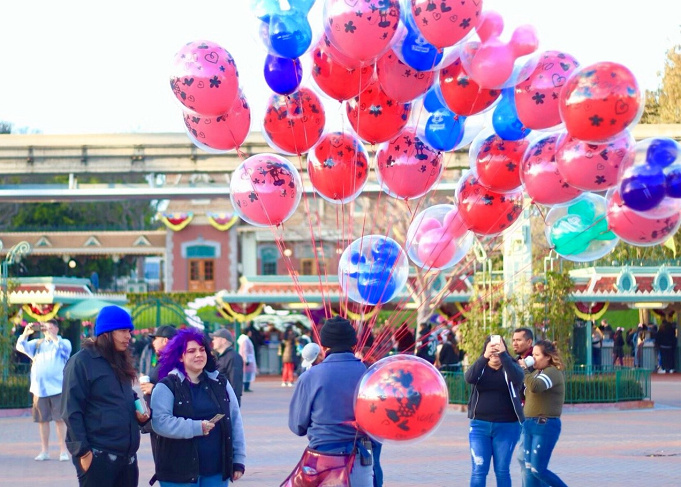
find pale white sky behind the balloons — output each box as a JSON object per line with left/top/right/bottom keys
{"left": 0, "top": 0, "right": 681, "bottom": 134}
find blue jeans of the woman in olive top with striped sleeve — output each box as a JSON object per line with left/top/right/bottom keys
{"left": 523, "top": 418, "right": 567, "bottom": 487}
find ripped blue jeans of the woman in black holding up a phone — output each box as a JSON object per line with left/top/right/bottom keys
{"left": 468, "top": 419, "right": 520, "bottom": 487}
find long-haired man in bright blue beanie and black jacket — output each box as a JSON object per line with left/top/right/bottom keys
{"left": 62, "top": 306, "right": 149, "bottom": 487}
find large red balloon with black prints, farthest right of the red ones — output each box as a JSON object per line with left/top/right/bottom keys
{"left": 559, "top": 62, "right": 643, "bottom": 142}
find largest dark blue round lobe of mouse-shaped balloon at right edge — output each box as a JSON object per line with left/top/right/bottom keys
{"left": 620, "top": 164, "right": 667, "bottom": 211}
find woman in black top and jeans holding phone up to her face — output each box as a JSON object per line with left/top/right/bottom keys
{"left": 464, "top": 335, "right": 525, "bottom": 487}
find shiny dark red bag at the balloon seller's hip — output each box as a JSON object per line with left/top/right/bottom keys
{"left": 279, "top": 447, "right": 355, "bottom": 487}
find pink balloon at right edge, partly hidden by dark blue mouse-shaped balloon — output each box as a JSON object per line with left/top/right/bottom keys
{"left": 605, "top": 188, "right": 681, "bottom": 247}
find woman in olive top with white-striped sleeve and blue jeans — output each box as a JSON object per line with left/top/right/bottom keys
{"left": 523, "top": 340, "right": 567, "bottom": 487}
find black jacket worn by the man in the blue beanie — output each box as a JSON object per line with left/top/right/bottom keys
{"left": 62, "top": 347, "right": 140, "bottom": 457}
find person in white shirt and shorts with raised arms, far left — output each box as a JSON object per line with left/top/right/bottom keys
{"left": 16, "top": 320, "right": 71, "bottom": 462}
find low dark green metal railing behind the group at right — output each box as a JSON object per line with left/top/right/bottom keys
{"left": 442, "top": 366, "right": 652, "bottom": 404}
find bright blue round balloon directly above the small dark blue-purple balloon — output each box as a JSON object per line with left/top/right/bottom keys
{"left": 269, "top": 10, "right": 312, "bottom": 59}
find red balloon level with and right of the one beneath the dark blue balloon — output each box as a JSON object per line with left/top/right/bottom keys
{"left": 345, "top": 79, "right": 411, "bottom": 144}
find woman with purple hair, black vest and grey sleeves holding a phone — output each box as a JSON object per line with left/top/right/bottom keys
{"left": 151, "top": 328, "right": 246, "bottom": 487}
